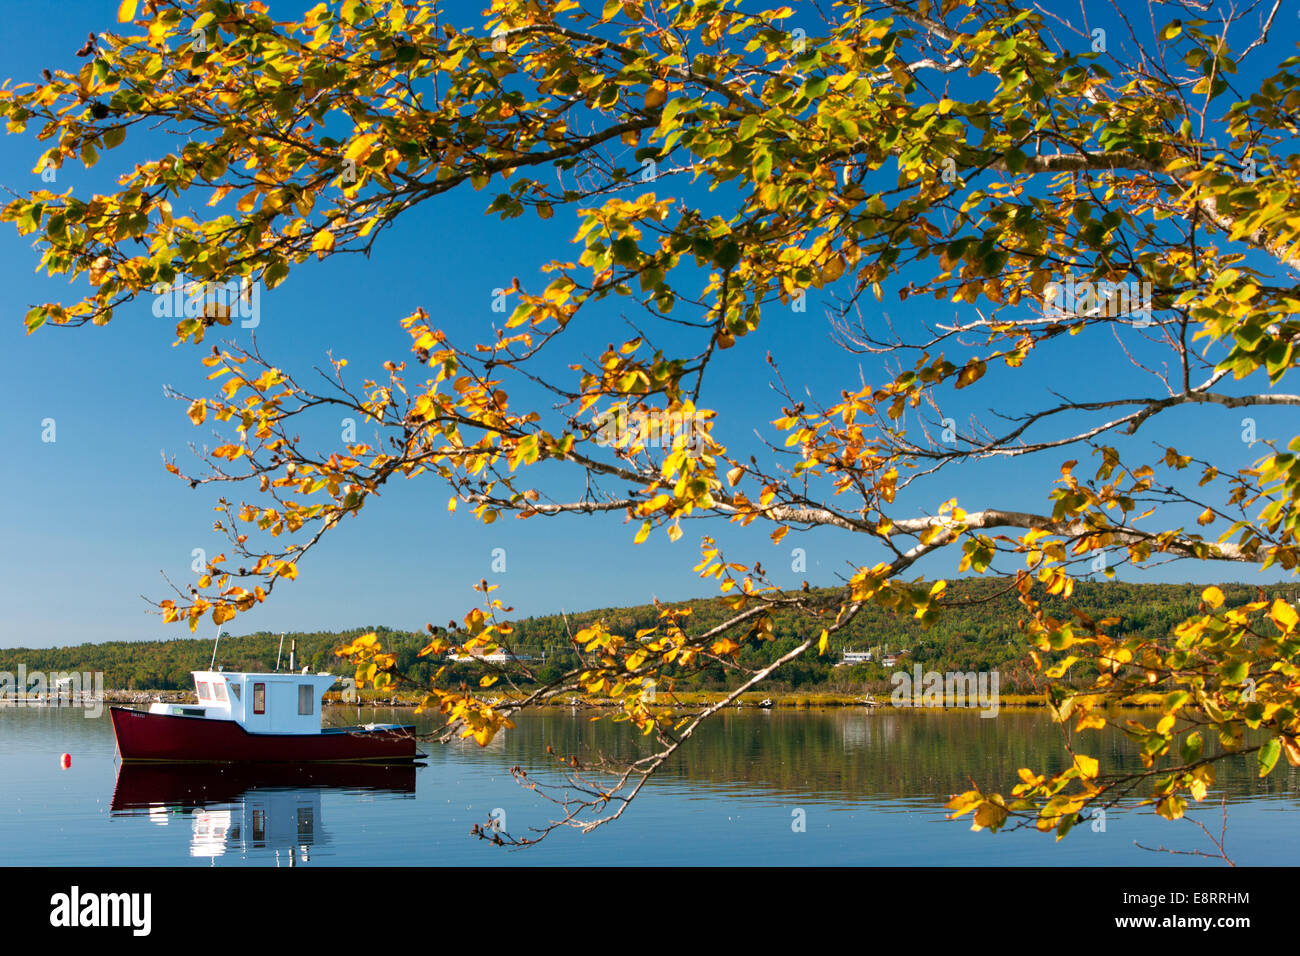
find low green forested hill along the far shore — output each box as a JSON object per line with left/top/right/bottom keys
{"left": 0, "top": 579, "right": 1295, "bottom": 691}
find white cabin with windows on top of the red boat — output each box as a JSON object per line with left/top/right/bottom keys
{"left": 150, "top": 671, "right": 337, "bottom": 734}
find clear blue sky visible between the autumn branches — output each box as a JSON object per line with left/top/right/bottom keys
{"left": 0, "top": 0, "right": 1296, "bottom": 646}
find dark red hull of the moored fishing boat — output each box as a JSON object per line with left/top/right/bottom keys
{"left": 109, "top": 708, "right": 425, "bottom": 763}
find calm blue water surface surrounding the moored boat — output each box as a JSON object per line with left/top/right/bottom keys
{"left": 0, "top": 708, "right": 1300, "bottom": 866}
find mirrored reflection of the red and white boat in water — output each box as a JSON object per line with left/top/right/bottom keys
{"left": 111, "top": 763, "right": 416, "bottom": 866}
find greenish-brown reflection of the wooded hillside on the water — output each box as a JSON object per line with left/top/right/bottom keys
{"left": 434, "top": 708, "right": 1300, "bottom": 814}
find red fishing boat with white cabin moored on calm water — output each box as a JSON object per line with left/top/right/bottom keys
{"left": 109, "top": 670, "right": 425, "bottom": 763}
